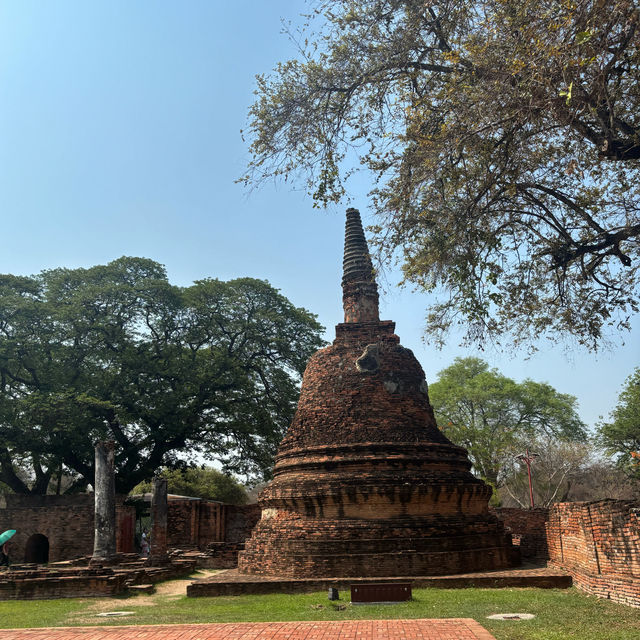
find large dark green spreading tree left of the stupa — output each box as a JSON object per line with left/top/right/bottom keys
{"left": 0, "top": 258, "right": 322, "bottom": 493}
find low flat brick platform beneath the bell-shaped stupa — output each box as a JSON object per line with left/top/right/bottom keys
{"left": 187, "top": 565, "right": 572, "bottom": 598}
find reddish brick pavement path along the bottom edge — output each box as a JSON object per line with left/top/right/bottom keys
{"left": 0, "top": 618, "right": 495, "bottom": 640}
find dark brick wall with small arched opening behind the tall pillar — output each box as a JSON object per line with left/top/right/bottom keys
{"left": 0, "top": 494, "right": 135, "bottom": 563}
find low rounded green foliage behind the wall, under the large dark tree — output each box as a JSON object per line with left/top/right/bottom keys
{"left": 131, "top": 467, "right": 248, "bottom": 504}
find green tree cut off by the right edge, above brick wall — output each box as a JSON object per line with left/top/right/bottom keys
{"left": 598, "top": 367, "right": 640, "bottom": 479}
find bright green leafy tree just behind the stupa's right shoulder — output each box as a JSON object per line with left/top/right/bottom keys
{"left": 429, "top": 358, "right": 586, "bottom": 488}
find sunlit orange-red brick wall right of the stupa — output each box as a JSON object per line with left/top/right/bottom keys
{"left": 495, "top": 500, "right": 640, "bottom": 607}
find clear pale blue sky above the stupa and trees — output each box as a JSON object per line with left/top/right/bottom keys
{"left": 0, "top": 0, "right": 640, "bottom": 436}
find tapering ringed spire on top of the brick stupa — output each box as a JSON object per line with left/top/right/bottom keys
{"left": 342, "top": 209, "right": 380, "bottom": 322}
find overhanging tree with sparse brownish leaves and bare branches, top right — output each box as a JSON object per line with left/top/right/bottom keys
{"left": 244, "top": 0, "right": 640, "bottom": 349}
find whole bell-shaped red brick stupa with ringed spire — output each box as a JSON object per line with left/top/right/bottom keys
{"left": 238, "top": 209, "right": 516, "bottom": 577}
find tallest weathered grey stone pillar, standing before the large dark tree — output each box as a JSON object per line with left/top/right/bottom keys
{"left": 91, "top": 440, "right": 116, "bottom": 563}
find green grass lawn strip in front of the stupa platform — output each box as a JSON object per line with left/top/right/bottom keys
{"left": 0, "top": 582, "right": 640, "bottom": 640}
